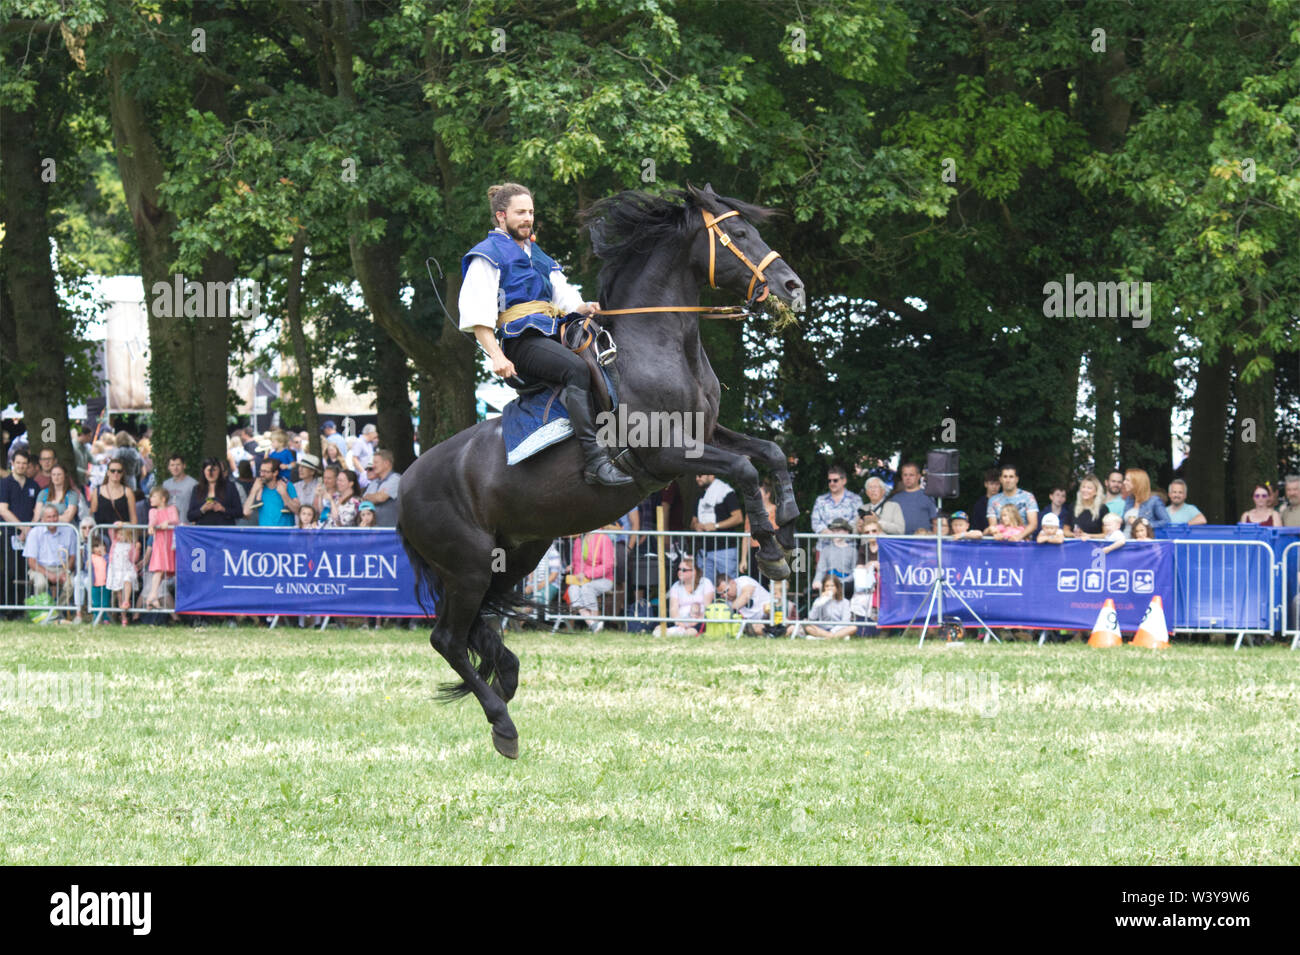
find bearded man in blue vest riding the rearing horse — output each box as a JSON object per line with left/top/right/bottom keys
{"left": 459, "top": 182, "right": 632, "bottom": 487}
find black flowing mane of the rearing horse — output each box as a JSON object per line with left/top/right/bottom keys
{"left": 581, "top": 188, "right": 775, "bottom": 301}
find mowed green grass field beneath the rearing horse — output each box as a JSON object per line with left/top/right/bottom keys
{"left": 0, "top": 624, "right": 1300, "bottom": 865}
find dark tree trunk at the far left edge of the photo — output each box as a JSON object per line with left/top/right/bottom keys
{"left": 0, "top": 77, "right": 75, "bottom": 474}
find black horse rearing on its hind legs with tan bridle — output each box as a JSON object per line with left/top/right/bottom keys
{"left": 398, "top": 186, "right": 805, "bottom": 759}
